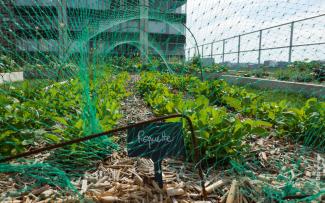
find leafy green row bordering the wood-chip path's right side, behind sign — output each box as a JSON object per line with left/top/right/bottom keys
{"left": 137, "top": 73, "right": 272, "bottom": 160}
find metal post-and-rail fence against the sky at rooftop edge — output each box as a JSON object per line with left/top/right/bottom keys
{"left": 185, "top": 14, "right": 325, "bottom": 67}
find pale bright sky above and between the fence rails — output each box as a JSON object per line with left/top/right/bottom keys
{"left": 186, "top": 0, "right": 325, "bottom": 62}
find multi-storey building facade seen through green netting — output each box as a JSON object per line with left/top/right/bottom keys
{"left": 0, "top": 0, "right": 186, "bottom": 59}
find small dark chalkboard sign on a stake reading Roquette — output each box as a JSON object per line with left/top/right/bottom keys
{"left": 127, "top": 122, "right": 185, "bottom": 187}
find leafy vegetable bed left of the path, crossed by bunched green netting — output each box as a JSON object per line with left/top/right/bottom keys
{"left": 0, "top": 73, "right": 129, "bottom": 156}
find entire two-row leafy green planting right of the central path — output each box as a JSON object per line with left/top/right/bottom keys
{"left": 137, "top": 72, "right": 325, "bottom": 160}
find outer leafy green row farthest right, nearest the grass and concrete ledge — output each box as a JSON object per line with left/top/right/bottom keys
{"left": 144, "top": 70, "right": 325, "bottom": 148}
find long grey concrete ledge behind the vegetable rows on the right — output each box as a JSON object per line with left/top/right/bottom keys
{"left": 218, "top": 75, "right": 325, "bottom": 98}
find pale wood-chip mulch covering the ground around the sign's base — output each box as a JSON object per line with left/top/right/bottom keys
{"left": 3, "top": 138, "right": 325, "bottom": 203}
